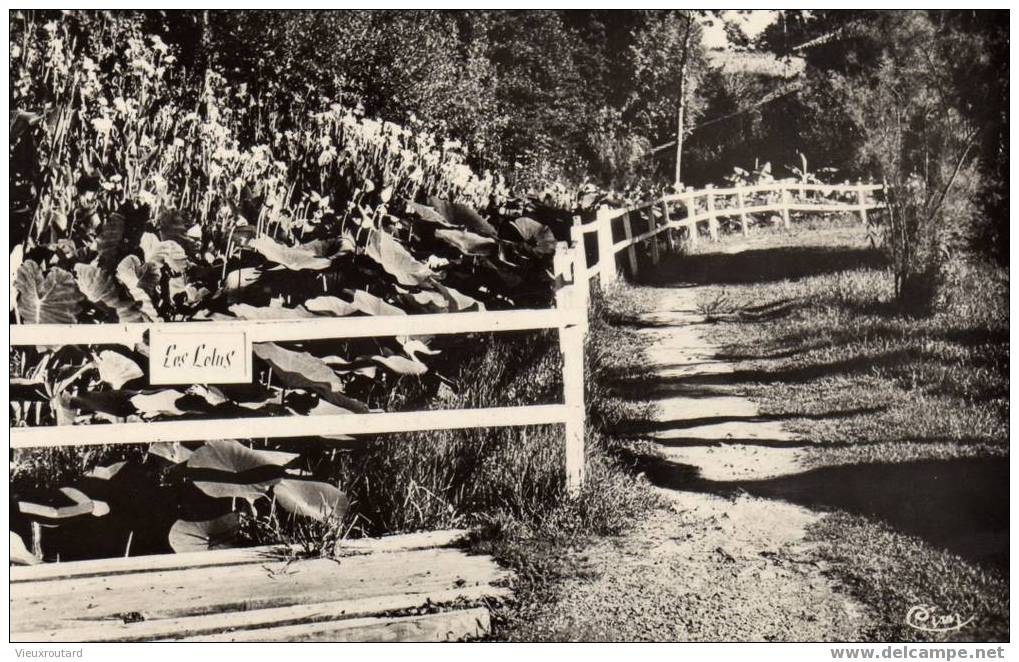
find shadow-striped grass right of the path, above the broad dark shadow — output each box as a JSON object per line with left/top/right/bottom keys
{"left": 685, "top": 219, "right": 1009, "bottom": 465}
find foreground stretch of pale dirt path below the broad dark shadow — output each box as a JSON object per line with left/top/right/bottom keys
{"left": 515, "top": 491, "right": 866, "bottom": 642}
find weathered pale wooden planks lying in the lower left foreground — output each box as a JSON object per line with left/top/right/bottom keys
{"left": 10, "top": 531, "right": 511, "bottom": 643}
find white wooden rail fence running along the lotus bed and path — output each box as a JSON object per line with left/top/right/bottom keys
{"left": 10, "top": 182, "right": 880, "bottom": 494}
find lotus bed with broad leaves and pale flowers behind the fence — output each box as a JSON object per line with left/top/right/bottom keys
{"left": 10, "top": 13, "right": 571, "bottom": 550}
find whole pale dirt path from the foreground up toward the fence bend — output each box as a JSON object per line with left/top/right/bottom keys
{"left": 505, "top": 279, "right": 867, "bottom": 642}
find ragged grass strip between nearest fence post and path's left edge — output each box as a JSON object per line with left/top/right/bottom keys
{"left": 466, "top": 286, "right": 661, "bottom": 640}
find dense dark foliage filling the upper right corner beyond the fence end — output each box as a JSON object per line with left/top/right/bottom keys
{"left": 760, "top": 10, "right": 1009, "bottom": 264}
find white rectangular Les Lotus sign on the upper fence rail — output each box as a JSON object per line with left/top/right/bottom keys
{"left": 149, "top": 331, "right": 252, "bottom": 384}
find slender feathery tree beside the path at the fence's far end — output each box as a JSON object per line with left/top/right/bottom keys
{"left": 835, "top": 11, "right": 980, "bottom": 312}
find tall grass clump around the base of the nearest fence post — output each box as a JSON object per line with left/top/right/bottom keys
{"left": 311, "top": 285, "right": 654, "bottom": 539}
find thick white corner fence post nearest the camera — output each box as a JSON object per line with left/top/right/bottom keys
{"left": 552, "top": 241, "right": 587, "bottom": 496}
